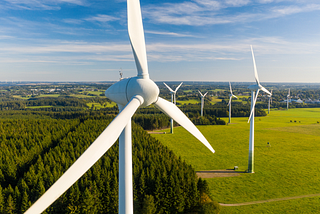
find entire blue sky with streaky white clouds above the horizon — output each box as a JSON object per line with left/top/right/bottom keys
{"left": 0, "top": 0, "right": 320, "bottom": 82}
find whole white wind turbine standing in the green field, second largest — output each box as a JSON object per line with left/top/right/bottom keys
{"left": 248, "top": 45, "right": 271, "bottom": 173}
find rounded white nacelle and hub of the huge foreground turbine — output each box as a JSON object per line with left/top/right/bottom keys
{"left": 105, "top": 77, "right": 160, "bottom": 107}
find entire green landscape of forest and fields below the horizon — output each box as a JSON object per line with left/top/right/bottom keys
{"left": 0, "top": 82, "right": 320, "bottom": 213}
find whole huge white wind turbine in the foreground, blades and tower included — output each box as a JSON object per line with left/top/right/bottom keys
{"left": 25, "top": 0, "right": 214, "bottom": 214}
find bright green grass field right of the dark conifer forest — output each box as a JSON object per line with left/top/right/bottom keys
{"left": 153, "top": 109, "right": 320, "bottom": 213}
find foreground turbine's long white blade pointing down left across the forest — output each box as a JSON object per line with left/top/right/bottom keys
{"left": 25, "top": 96, "right": 143, "bottom": 214}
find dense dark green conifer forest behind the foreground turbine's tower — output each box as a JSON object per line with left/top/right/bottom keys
{"left": 0, "top": 115, "right": 218, "bottom": 214}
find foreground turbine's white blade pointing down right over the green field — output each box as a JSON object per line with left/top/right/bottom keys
{"left": 154, "top": 97, "right": 214, "bottom": 153}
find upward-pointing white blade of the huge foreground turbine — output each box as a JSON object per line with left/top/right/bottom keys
{"left": 127, "top": 0, "right": 149, "bottom": 78}
